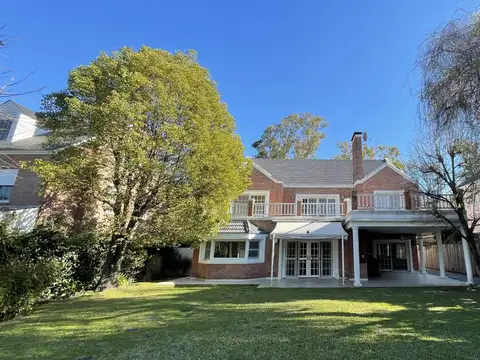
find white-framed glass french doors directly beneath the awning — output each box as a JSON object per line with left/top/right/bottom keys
{"left": 285, "top": 241, "right": 332, "bottom": 277}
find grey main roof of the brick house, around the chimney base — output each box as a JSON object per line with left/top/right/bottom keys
{"left": 253, "top": 159, "right": 385, "bottom": 187}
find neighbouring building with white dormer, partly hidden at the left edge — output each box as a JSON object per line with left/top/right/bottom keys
{"left": 0, "top": 100, "right": 49, "bottom": 230}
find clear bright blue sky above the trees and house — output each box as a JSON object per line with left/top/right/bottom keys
{"left": 0, "top": 0, "right": 480, "bottom": 158}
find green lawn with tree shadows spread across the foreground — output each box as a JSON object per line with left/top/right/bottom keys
{"left": 0, "top": 284, "right": 480, "bottom": 360}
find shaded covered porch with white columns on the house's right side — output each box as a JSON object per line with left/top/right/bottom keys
{"left": 345, "top": 211, "right": 473, "bottom": 287}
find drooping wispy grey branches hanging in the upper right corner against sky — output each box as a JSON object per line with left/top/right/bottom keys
{"left": 418, "top": 14, "right": 480, "bottom": 126}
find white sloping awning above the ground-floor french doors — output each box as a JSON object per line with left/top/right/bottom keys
{"left": 272, "top": 222, "right": 347, "bottom": 239}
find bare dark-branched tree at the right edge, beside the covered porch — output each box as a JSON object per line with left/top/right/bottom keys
{"left": 408, "top": 120, "right": 480, "bottom": 267}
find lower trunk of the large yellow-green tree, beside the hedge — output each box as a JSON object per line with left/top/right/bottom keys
{"left": 96, "top": 235, "right": 127, "bottom": 291}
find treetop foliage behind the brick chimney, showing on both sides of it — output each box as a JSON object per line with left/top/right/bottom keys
{"left": 333, "top": 141, "right": 405, "bottom": 170}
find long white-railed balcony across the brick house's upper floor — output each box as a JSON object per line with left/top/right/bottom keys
{"left": 230, "top": 192, "right": 453, "bottom": 218}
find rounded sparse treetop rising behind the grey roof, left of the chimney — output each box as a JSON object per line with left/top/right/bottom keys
{"left": 252, "top": 113, "right": 328, "bottom": 159}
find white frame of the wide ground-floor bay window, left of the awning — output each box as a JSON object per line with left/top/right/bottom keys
{"left": 198, "top": 234, "right": 267, "bottom": 264}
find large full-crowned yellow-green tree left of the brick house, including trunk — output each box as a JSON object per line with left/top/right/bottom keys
{"left": 33, "top": 47, "right": 251, "bottom": 289}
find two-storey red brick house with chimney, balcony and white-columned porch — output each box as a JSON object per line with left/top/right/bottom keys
{"left": 192, "top": 132, "right": 473, "bottom": 286}
